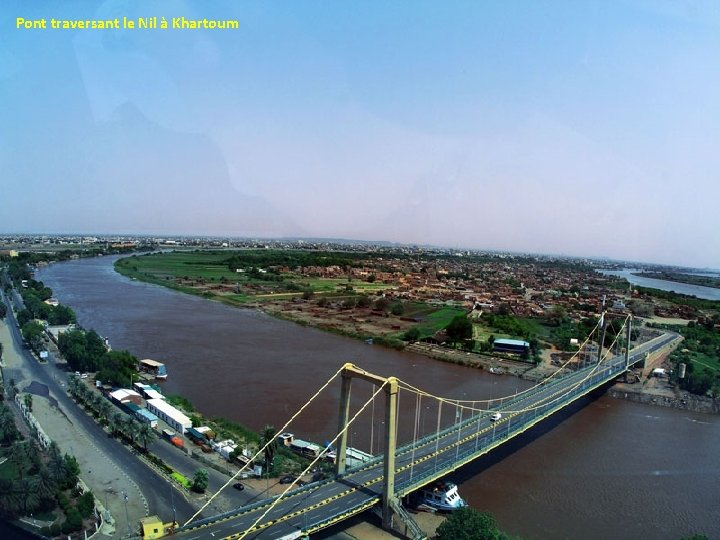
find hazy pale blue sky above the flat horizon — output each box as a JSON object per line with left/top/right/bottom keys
{"left": 0, "top": 0, "right": 720, "bottom": 268}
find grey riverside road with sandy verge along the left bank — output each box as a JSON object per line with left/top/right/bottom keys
{"left": 0, "top": 280, "right": 268, "bottom": 535}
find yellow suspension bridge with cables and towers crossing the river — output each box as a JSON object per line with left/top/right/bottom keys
{"left": 175, "top": 313, "right": 676, "bottom": 539}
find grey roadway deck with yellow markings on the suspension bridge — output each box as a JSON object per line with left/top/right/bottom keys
{"left": 177, "top": 334, "right": 677, "bottom": 539}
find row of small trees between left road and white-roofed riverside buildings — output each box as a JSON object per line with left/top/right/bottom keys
{"left": 68, "top": 376, "right": 157, "bottom": 452}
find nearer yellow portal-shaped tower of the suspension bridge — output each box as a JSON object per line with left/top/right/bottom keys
{"left": 335, "top": 362, "right": 398, "bottom": 528}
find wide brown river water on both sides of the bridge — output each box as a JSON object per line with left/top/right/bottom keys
{"left": 37, "top": 257, "right": 720, "bottom": 540}
